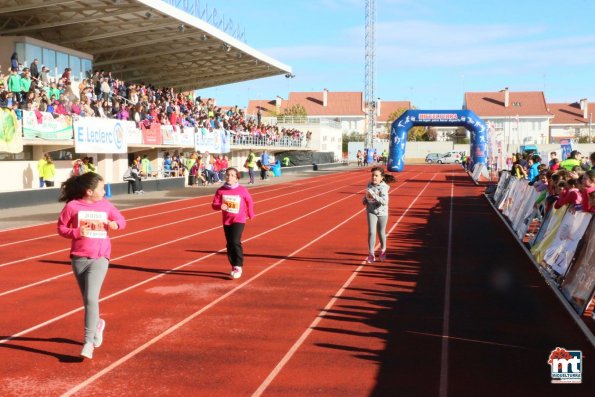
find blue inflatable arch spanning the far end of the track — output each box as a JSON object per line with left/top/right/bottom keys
{"left": 387, "top": 110, "right": 488, "bottom": 172}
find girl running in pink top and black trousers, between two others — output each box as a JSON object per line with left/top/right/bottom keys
{"left": 212, "top": 167, "right": 254, "bottom": 279}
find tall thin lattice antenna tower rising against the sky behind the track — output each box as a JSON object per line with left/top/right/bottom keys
{"left": 364, "top": 0, "right": 376, "bottom": 148}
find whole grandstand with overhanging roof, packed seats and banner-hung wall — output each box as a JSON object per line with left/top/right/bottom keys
{"left": 0, "top": 0, "right": 306, "bottom": 191}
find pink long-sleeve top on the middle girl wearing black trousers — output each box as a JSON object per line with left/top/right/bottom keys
{"left": 212, "top": 184, "right": 254, "bottom": 225}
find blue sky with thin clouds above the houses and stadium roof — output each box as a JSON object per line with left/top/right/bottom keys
{"left": 198, "top": 0, "right": 595, "bottom": 109}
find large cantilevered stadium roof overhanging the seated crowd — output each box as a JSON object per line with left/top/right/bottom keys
{"left": 0, "top": 0, "right": 291, "bottom": 91}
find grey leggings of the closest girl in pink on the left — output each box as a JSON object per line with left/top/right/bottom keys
{"left": 72, "top": 256, "right": 109, "bottom": 343}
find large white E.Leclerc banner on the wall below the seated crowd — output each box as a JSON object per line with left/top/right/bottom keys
{"left": 74, "top": 117, "right": 130, "bottom": 153}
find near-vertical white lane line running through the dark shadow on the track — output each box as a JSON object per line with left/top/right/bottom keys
{"left": 439, "top": 173, "right": 455, "bottom": 397}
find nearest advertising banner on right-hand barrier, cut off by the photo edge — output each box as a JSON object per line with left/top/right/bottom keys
{"left": 562, "top": 222, "right": 595, "bottom": 314}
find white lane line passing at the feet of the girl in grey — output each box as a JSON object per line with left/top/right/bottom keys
{"left": 252, "top": 174, "right": 436, "bottom": 397}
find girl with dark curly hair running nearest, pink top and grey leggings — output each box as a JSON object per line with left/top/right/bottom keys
{"left": 58, "top": 172, "right": 126, "bottom": 359}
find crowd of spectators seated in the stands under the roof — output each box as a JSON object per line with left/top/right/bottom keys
{"left": 0, "top": 53, "right": 311, "bottom": 146}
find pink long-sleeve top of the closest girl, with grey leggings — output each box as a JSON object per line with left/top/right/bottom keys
{"left": 58, "top": 199, "right": 126, "bottom": 259}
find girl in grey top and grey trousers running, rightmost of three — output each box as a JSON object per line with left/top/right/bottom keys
{"left": 362, "top": 167, "right": 395, "bottom": 263}
